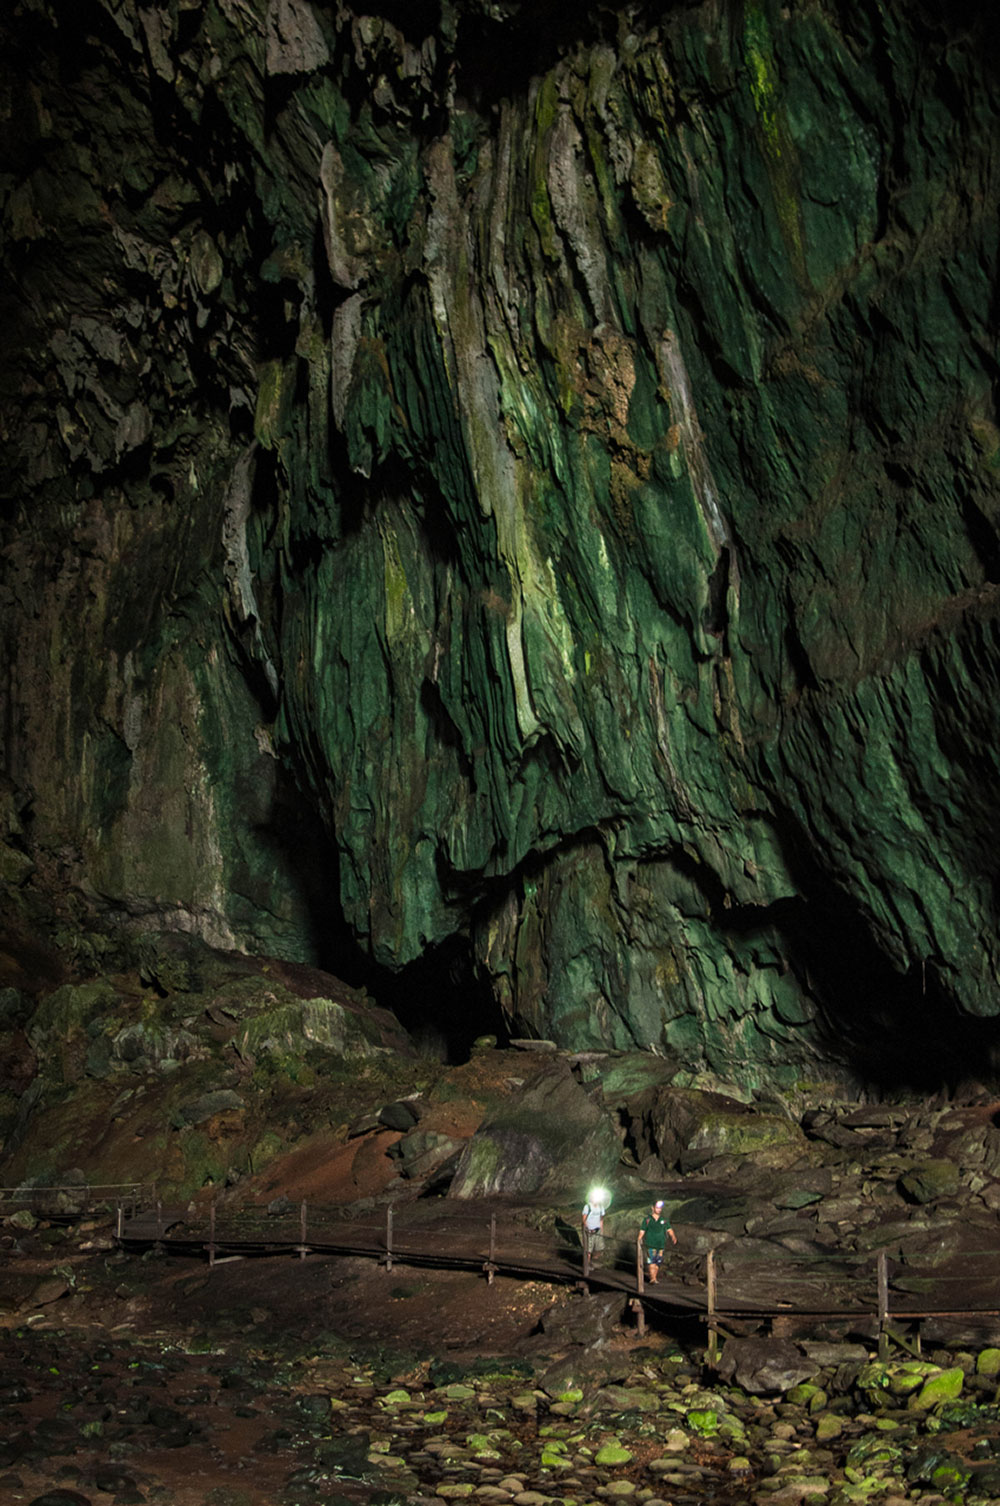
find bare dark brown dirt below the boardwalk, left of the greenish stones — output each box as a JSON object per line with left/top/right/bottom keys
{"left": 0, "top": 1234, "right": 658, "bottom": 1506}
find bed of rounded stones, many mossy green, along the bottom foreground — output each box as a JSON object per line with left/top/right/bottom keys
{"left": 15, "top": 1283, "right": 997, "bottom": 1506}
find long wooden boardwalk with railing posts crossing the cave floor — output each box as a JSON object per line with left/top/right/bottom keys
{"left": 13, "top": 1184, "right": 1000, "bottom": 1352}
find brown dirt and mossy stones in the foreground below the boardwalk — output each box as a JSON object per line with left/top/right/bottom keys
{"left": 0, "top": 1168, "right": 1000, "bottom": 1506}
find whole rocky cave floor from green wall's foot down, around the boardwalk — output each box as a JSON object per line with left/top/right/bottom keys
{"left": 9, "top": 958, "right": 1000, "bottom": 1506}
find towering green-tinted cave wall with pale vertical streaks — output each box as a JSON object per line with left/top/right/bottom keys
{"left": 0, "top": 0, "right": 1000, "bottom": 1086}
